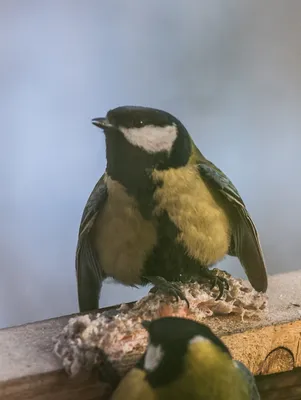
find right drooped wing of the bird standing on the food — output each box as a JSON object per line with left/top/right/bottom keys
{"left": 198, "top": 160, "right": 267, "bottom": 292}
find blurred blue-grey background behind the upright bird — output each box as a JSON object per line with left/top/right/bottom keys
{"left": 0, "top": 0, "right": 301, "bottom": 327}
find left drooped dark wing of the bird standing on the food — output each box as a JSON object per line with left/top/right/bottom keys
{"left": 75, "top": 175, "right": 107, "bottom": 312}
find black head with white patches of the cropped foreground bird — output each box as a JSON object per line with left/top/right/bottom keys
{"left": 138, "top": 317, "right": 231, "bottom": 387}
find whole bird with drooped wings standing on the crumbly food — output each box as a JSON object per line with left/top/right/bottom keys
{"left": 76, "top": 106, "right": 267, "bottom": 311}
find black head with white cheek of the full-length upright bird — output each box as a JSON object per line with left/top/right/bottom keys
{"left": 92, "top": 106, "right": 191, "bottom": 176}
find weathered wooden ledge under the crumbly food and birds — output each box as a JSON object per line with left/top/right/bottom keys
{"left": 0, "top": 271, "right": 301, "bottom": 400}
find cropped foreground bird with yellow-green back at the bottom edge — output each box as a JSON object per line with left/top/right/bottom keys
{"left": 111, "top": 317, "right": 260, "bottom": 400}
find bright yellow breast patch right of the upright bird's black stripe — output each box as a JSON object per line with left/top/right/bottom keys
{"left": 153, "top": 166, "right": 230, "bottom": 265}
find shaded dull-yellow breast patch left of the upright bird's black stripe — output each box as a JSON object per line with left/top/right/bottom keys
{"left": 95, "top": 177, "right": 157, "bottom": 285}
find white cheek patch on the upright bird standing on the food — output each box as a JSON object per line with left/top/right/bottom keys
{"left": 118, "top": 124, "right": 177, "bottom": 153}
